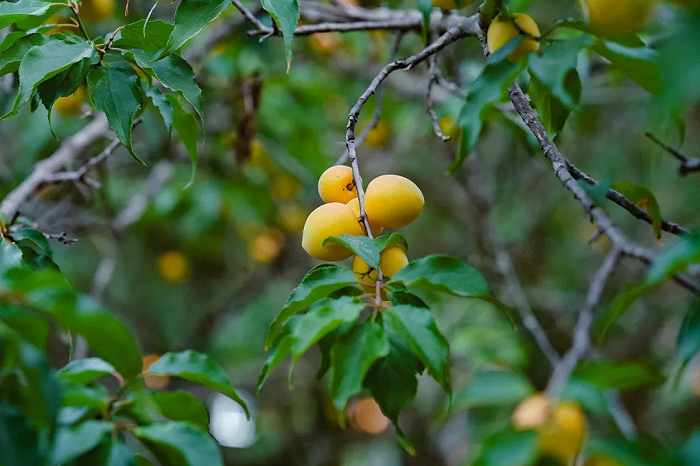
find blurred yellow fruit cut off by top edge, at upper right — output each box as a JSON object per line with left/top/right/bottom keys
{"left": 583, "top": 0, "right": 655, "bottom": 36}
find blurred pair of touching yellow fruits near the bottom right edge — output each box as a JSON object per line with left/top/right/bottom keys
{"left": 513, "top": 394, "right": 588, "bottom": 462}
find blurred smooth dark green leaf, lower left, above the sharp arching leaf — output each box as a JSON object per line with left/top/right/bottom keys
{"left": 70, "top": 296, "right": 142, "bottom": 381}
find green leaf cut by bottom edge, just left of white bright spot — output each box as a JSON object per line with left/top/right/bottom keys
{"left": 132, "top": 422, "right": 223, "bottom": 466}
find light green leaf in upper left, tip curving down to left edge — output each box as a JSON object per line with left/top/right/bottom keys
{"left": 0, "top": 36, "right": 97, "bottom": 119}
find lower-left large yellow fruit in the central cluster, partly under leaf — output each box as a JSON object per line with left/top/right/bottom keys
{"left": 301, "top": 202, "right": 364, "bottom": 262}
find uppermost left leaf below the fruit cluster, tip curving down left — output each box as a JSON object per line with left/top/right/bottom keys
{"left": 265, "top": 264, "right": 357, "bottom": 349}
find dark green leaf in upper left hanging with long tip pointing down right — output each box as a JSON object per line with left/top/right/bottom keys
{"left": 87, "top": 66, "right": 143, "bottom": 164}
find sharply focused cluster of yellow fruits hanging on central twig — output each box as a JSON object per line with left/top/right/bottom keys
{"left": 301, "top": 165, "right": 425, "bottom": 286}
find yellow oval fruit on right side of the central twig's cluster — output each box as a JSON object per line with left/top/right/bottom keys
{"left": 365, "top": 175, "right": 425, "bottom": 228}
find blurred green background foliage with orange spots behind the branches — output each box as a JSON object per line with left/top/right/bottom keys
{"left": 0, "top": 0, "right": 700, "bottom": 466}
